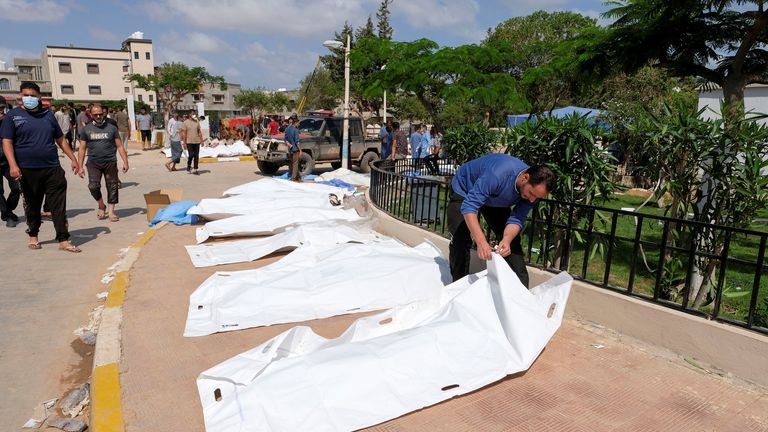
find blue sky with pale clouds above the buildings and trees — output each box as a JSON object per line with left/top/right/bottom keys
{"left": 0, "top": 0, "right": 606, "bottom": 89}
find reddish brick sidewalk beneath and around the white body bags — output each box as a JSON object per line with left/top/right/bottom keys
{"left": 121, "top": 224, "right": 768, "bottom": 432}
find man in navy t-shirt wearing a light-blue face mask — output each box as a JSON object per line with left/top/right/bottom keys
{"left": 0, "top": 81, "right": 80, "bottom": 252}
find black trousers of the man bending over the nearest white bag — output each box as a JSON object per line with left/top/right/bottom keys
{"left": 448, "top": 192, "right": 528, "bottom": 287}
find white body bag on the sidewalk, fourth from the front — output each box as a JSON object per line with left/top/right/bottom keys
{"left": 195, "top": 207, "right": 365, "bottom": 243}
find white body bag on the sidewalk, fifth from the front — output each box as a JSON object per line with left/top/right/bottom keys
{"left": 187, "top": 191, "right": 334, "bottom": 220}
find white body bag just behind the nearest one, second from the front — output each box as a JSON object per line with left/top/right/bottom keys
{"left": 184, "top": 239, "right": 450, "bottom": 336}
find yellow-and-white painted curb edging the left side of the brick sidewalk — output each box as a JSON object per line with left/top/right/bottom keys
{"left": 89, "top": 222, "right": 167, "bottom": 432}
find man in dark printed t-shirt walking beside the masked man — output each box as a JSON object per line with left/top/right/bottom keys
{"left": 78, "top": 105, "right": 128, "bottom": 222}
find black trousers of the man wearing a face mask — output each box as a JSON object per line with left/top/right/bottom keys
{"left": 21, "top": 166, "right": 69, "bottom": 242}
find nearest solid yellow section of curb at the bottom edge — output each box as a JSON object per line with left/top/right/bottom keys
{"left": 89, "top": 363, "right": 125, "bottom": 432}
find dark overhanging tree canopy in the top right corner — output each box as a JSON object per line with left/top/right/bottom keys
{"left": 580, "top": 0, "right": 768, "bottom": 118}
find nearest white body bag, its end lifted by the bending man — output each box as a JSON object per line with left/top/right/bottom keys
{"left": 197, "top": 254, "right": 572, "bottom": 432}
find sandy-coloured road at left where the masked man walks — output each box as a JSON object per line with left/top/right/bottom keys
{"left": 0, "top": 143, "right": 270, "bottom": 430}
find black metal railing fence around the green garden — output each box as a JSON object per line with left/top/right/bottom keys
{"left": 369, "top": 159, "right": 768, "bottom": 334}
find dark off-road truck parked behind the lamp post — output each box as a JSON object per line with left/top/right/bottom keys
{"left": 251, "top": 116, "right": 381, "bottom": 175}
